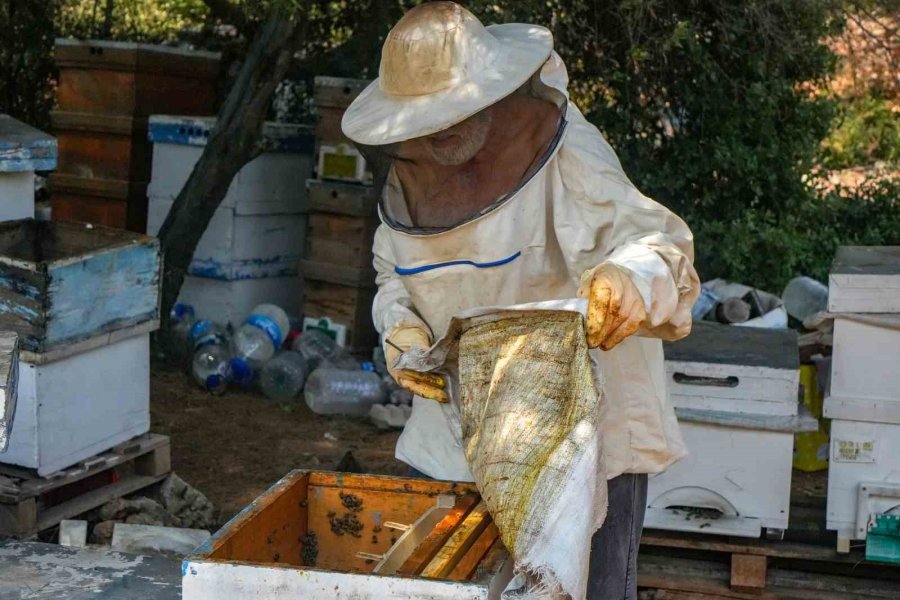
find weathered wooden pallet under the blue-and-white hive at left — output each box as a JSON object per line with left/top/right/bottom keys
{"left": 0, "top": 433, "right": 171, "bottom": 539}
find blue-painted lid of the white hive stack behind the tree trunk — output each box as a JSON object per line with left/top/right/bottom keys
{"left": 149, "top": 115, "right": 315, "bottom": 154}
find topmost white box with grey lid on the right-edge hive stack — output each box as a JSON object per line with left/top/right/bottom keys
{"left": 828, "top": 246, "right": 900, "bottom": 313}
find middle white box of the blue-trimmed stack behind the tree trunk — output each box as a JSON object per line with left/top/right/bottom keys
{"left": 147, "top": 198, "right": 307, "bottom": 280}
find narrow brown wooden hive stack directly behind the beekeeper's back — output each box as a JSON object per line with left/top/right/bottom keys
{"left": 302, "top": 77, "right": 378, "bottom": 352}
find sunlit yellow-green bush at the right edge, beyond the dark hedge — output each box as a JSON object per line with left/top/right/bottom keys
{"left": 822, "top": 96, "right": 900, "bottom": 169}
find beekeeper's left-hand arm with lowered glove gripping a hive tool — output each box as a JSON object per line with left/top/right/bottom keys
{"left": 372, "top": 225, "right": 447, "bottom": 402}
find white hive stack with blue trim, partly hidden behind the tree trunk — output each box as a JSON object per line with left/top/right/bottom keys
{"left": 147, "top": 115, "right": 313, "bottom": 325}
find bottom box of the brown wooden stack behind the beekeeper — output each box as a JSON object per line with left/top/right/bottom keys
{"left": 303, "top": 277, "right": 378, "bottom": 354}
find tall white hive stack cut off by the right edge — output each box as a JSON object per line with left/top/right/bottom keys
{"left": 824, "top": 246, "right": 900, "bottom": 561}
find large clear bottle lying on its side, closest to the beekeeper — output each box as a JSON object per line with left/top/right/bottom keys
{"left": 304, "top": 368, "right": 386, "bottom": 417}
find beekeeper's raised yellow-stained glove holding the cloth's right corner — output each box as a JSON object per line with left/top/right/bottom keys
{"left": 578, "top": 263, "right": 647, "bottom": 350}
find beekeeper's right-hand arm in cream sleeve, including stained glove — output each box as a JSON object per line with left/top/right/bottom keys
{"left": 554, "top": 111, "right": 700, "bottom": 350}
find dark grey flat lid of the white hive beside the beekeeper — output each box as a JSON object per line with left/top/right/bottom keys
{"left": 663, "top": 321, "right": 800, "bottom": 371}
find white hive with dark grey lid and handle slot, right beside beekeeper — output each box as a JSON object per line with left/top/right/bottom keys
{"left": 644, "top": 322, "right": 804, "bottom": 537}
